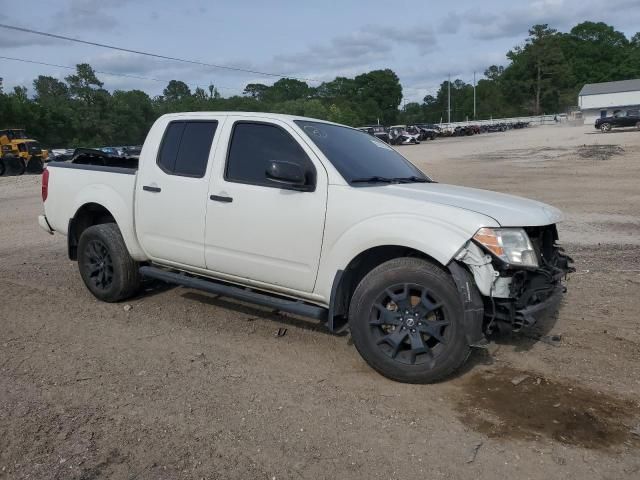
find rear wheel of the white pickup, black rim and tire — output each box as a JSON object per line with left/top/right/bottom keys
{"left": 78, "top": 223, "right": 140, "bottom": 302}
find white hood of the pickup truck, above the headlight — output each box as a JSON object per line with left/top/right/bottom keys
{"left": 374, "top": 183, "right": 563, "bottom": 227}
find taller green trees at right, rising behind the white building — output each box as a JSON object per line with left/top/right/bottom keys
{"left": 400, "top": 22, "right": 640, "bottom": 123}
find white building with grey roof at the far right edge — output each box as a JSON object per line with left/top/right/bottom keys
{"left": 578, "top": 79, "right": 640, "bottom": 124}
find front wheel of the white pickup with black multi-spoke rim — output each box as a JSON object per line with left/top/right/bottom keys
{"left": 349, "top": 258, "right": 470, "bottom": 383}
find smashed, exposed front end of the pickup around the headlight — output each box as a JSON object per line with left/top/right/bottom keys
{"left": 456, "top": 225, "right": 574, "bottom": 334}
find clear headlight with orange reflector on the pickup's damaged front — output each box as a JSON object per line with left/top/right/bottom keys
{"left": 473, "top": 228, "right": 538, "bottom": 267}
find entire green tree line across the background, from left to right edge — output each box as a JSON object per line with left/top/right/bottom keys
{"left": 0, "top": 22, "right": 640, "bottom": 147}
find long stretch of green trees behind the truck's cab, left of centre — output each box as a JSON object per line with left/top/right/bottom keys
{"left": 0, "top": 64, "right": 402, "bottom": 147}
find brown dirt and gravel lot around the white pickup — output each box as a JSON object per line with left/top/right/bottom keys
{"left": 0, "top": 127, "right": 640, "bottom": 480}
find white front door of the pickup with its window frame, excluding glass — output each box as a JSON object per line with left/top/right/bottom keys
{"left": 204, "top": 115, "right": 328, "bottom": 293}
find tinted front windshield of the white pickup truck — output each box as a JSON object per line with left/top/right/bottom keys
{"left": 295, "top": 120, "right": 430, "bottom": 183}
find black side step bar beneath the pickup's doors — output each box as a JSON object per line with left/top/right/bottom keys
{"left": 140, "top": 267, "right": 328, "bottom": 320}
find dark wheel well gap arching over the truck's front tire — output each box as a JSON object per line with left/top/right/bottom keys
{"left": 329, "top": 245, "right": 446, "bottom": 331}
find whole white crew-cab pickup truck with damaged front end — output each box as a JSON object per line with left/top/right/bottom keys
{"left": 39, "top": 112, "right": 571, "bottom": 383}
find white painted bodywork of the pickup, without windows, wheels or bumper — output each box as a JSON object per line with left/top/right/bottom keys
{"left": 43, "top": 112, "right": 562, "bottom": 306}
